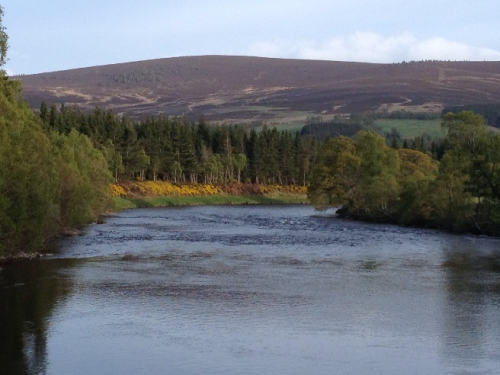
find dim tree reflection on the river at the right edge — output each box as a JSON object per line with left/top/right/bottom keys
{"left": 441, "top": 238, "right": 500, "bottom": 374}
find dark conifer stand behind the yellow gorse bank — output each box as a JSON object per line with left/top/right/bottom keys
{"left": 39, "top": 103, "right": 319, "bottom": 185}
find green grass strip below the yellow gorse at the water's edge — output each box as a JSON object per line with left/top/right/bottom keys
{"left": 114, "top": 194, "right": 309, "bottom": 210}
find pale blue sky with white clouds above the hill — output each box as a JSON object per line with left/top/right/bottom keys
{"left": 0, "top": 0, "right": 500, "bottom": 75}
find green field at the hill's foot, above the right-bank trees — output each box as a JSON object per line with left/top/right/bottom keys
{"left": 375, "top": 119, "right": 446, "bottom": 138}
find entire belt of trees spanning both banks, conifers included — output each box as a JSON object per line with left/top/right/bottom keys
{"left": 5, "top": 78, "right": 500, "bottom": 254}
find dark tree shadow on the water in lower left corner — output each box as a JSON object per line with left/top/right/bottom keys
{"left": 0, "top": 260, "right": 76, "bottom": 375}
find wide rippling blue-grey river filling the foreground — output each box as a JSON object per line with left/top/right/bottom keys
{"left": 0, "top": 206, "right": 500, "bottom": 375}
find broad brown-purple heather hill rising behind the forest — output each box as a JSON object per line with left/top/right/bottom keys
{"left": 14, "top": 56, "right": 500, "bottom": 123}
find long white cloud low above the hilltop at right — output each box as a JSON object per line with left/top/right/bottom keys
{"left": 244, "top": 32, "right": 500, "bottom": 63}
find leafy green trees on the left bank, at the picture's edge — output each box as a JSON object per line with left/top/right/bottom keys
{"left": 0, "top": 7, "right": 112, "bottom": 256}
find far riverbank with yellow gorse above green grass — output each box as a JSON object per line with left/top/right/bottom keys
{"left": 111, "top": 181, "right": 309, "bottom": 210}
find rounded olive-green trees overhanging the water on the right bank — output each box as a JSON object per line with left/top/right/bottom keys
{"left": 309, "top": 111, "right": 500, "bottom": 235}
